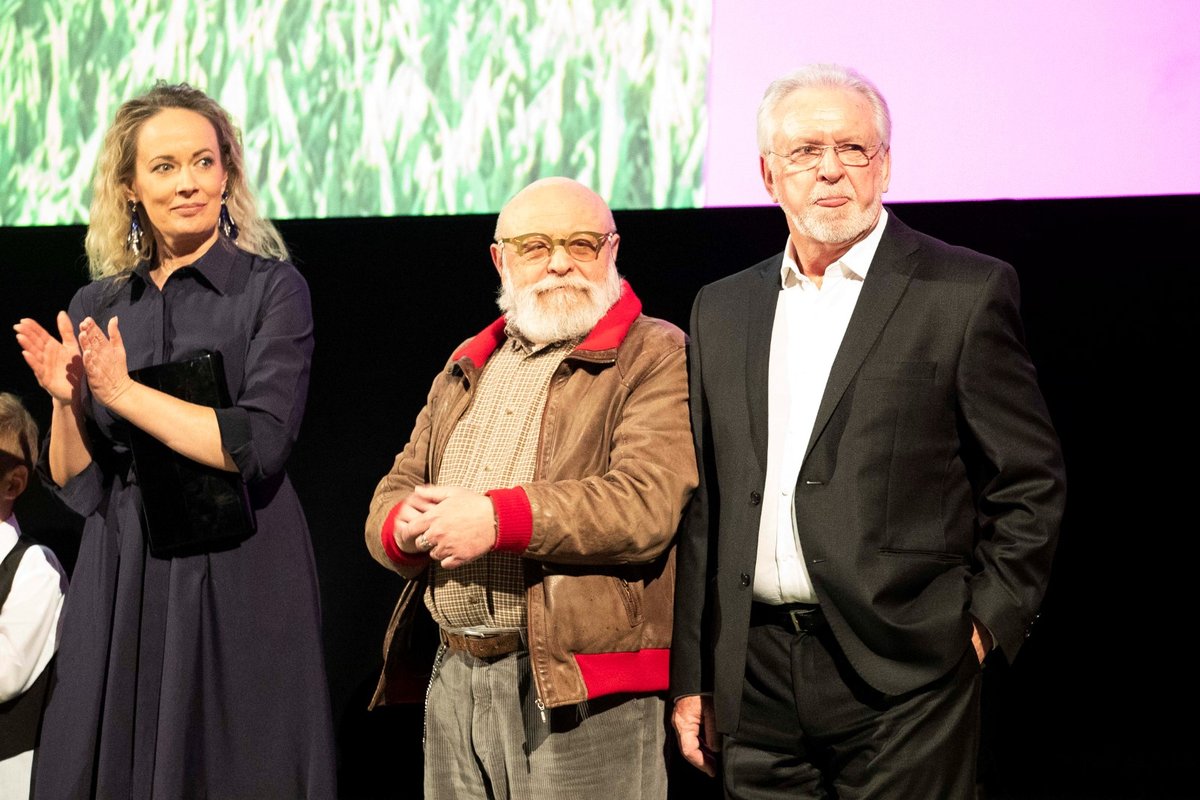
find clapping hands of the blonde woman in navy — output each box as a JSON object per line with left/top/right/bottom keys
{"left": 13, "top": 311, "right": 133, "bottom": 408}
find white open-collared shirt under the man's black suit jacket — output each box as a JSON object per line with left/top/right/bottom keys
{"left": 754, "top": 210, "right": 888, "bottom": 604}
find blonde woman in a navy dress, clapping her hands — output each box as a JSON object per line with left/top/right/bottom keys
{"left": 16, "top": 83, "right": 335, "bottom": 800}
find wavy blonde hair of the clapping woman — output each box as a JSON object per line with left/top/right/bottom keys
{"left": 84, "top": 80, "right": 288, "bottom": 279}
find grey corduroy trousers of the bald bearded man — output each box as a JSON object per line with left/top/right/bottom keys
{"left": 425, "top": 650, "right": 667, "bottom": 800}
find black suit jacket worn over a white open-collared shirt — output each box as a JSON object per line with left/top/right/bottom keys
{"left": 672, "top": 213, "right": 1066, "bottom": 732}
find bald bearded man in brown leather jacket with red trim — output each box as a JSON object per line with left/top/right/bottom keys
{"left": 366, "top": 178, "right": 696, "bottom": 800}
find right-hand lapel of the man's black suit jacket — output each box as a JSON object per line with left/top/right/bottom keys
{"left": 804, "top": 209, "right": 918, "bottom": 458}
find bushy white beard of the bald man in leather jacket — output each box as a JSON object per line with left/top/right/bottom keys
{"left": 496, "top": 264, "right": 620, "bottom": 344}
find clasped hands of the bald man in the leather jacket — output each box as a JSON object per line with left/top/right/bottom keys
{"left": 392, "top": 485, "right": 496, "bottom": 570}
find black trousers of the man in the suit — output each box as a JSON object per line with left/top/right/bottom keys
{"left": 721, "top": 613, "right": 980, "bottom": 800}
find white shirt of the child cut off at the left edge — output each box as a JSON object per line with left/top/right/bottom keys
{"left": 0, "top": 515, "right": 67, "bottom": 799}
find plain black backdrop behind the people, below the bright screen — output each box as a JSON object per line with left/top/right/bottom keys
{"left": 0, "top": 196, "right": 1200, "bottom": 800}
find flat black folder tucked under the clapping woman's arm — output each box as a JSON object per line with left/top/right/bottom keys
{"left": 130, "top": 353, "right": 254, "bottom": 558}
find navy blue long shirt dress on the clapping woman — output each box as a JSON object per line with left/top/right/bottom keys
{"left": 35, "top": 237, "right": 336, "bottom": 800}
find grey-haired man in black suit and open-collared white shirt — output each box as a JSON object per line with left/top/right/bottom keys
{"left": 671, "top": 65, "right": 1064, "bottom": 800}
